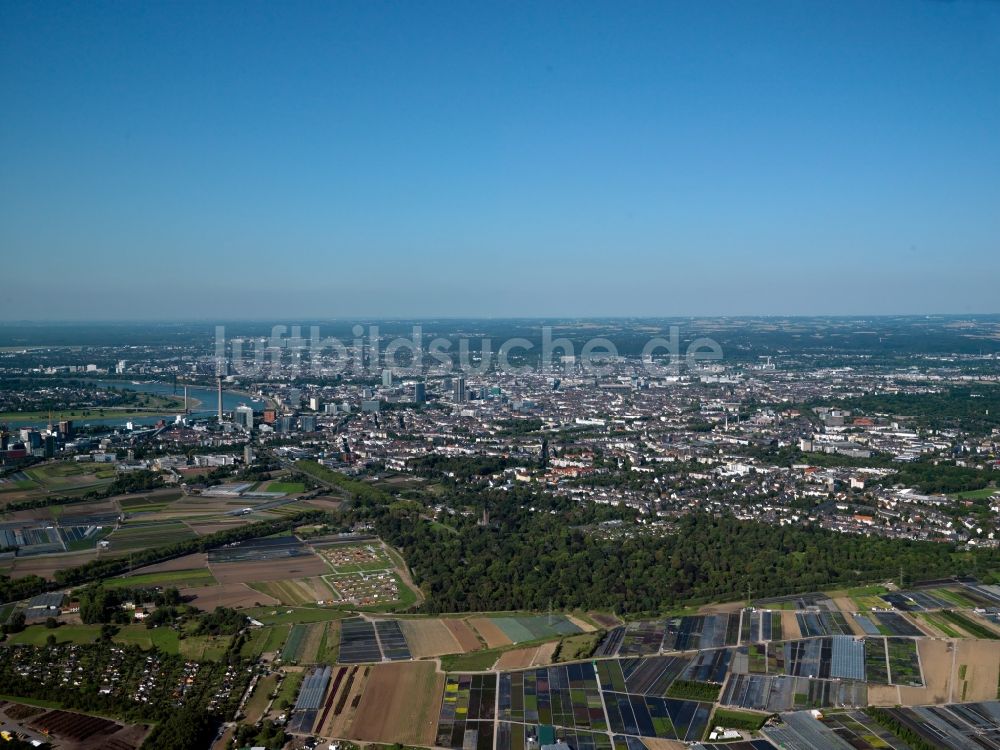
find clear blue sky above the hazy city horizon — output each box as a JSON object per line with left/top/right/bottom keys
{"left": 0, "top": 0, "right": 1000, "bottom": 320}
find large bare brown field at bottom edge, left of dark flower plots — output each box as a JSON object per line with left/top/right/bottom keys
{"left": 348, "top": 662, "right": 444, "bottom": 747}
